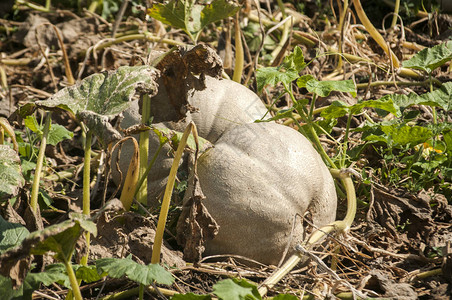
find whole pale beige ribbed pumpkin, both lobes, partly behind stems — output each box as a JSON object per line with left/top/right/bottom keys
{"left": 113, "top": 76, "right": 336, "bottom": 264}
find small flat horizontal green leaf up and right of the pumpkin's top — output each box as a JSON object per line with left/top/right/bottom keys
{"left": 297, "top": 75, "right": 356, "bottom": 97}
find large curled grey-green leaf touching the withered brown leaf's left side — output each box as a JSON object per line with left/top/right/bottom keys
{"left": 30, "top": 66, "right": 158, "bottom": 145}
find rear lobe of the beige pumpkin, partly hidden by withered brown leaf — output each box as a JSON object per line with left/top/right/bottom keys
{"left": 112, "top": 76, "right": 267, "bottom": 205}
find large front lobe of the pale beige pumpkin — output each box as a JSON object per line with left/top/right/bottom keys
{"left": 198, "top": 123, "right": 337, "bottom": 264}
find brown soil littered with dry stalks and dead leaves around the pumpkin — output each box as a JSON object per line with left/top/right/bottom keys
{"left": 0, "top": 1, "right": 452, "bottom": 299}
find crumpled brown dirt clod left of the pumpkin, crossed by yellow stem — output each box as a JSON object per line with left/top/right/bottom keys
{"left": 90, "top": 200, "right": 186, "bottom": 267}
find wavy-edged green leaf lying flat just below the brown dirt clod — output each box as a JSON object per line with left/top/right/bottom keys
{"left": 96, "top": 258, "right": 174, "bottom": 285}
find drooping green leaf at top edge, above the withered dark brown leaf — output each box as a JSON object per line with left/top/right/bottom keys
{"left": 148, "top": 0, "right": 240, "bottom": 42}
